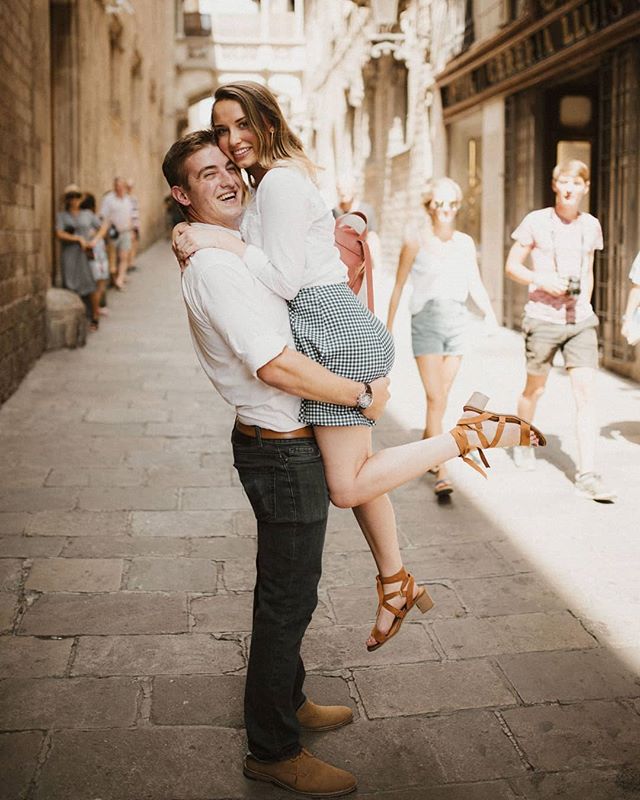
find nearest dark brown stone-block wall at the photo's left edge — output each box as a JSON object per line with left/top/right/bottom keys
{"left": 0, "top": 0, "right": 51, "bottom": 402}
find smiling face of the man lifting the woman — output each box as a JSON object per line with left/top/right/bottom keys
{"left": 171, "top": 144, "right": 244, "bottom": 228}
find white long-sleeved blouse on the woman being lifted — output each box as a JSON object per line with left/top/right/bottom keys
{"left": 240, "top": 166, "right": 347, "bottom": 300}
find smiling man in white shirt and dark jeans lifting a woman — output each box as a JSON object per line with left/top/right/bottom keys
{"left": 163, "top": 131, "right": 389, "bottom": 797}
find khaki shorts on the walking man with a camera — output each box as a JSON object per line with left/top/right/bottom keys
{"left": 522, "top": 314, "right": 599, "bottom": 375}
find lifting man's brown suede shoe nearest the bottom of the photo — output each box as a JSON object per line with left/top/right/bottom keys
{"left": 243, "top": 747, "right": 358, "bottom": 797}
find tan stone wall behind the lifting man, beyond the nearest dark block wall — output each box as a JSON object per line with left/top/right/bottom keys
{"left": 54, "top": 0, "right": 175, "bottom": 253}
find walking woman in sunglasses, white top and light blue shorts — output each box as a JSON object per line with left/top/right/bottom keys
{"left": 387, "top": 178, "right": 498, "bottom": 497}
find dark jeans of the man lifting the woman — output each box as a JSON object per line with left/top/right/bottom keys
{"left": 231, "top": 430, "right": 329, "bottom": 761}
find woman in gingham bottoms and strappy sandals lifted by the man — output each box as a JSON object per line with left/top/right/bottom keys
{"left": 174, "top": 81, "right": 539, "bottom": 650}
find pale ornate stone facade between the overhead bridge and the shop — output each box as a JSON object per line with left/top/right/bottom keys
{"left": 305, "top": 0, "right": 434, "bottom": 269}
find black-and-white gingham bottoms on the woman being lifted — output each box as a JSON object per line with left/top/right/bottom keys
{"left": 288, "top": 283, "right": 395, "bottom": 426}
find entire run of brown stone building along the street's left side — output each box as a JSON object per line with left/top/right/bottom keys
{"left": 0, "top": 0, "right": 175, "bottom": 402}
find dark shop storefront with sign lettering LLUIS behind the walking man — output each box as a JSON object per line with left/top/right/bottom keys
{"left": 438, "top": 0, "right": 640, "bottom": 379}
